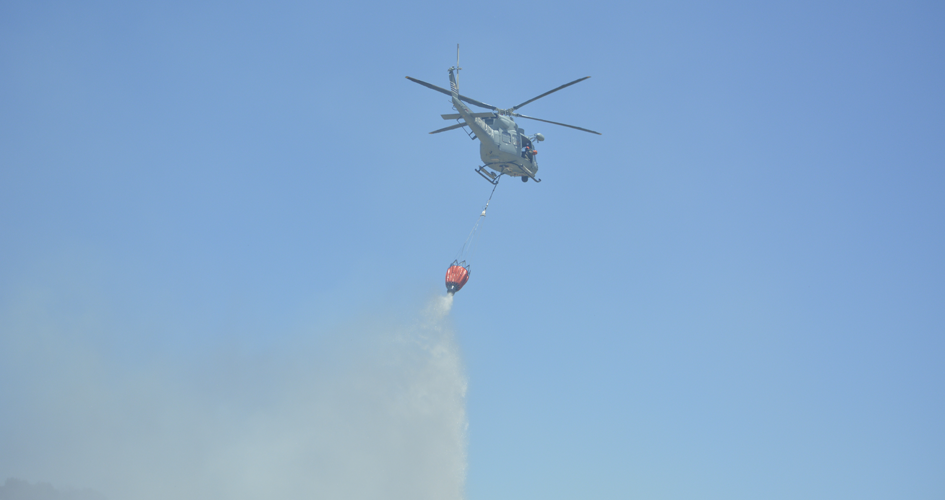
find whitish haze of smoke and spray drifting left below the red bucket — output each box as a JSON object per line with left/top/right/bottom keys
{"left": 0, "top": 290, "right": 467, "bottom": 500}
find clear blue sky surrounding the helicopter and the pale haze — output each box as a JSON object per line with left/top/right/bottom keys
{"left": 0, "top": 1, "right": 945, "bottom": 500}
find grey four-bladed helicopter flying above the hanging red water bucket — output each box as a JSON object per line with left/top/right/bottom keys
{"left": 407, "top": 45, "right": 601, "bottom": 184}
